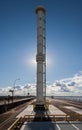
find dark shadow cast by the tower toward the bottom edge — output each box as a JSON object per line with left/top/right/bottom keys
{"left": 24, "top": 110, "right": 57, "bottom": 130}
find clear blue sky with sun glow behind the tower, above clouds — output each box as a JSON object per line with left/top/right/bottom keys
{"left": 0, "top": 0, "right": 82, "bottom": 95}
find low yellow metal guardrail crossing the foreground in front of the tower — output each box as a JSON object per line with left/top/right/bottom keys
{"left": 7, "top": 114, "right": 82, "bottom": 130}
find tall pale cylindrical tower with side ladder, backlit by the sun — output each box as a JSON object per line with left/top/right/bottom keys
{"left": 36, "top": 6, "right": 46, "bottom": 110}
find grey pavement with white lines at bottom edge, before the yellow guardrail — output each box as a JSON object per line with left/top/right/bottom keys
{"left": 20, "top": 122, "right": 82, "bottom": 130}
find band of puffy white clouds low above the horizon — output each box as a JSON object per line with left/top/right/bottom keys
{"left": 0, "top": 71, "right": 82, "bottom": 96}
